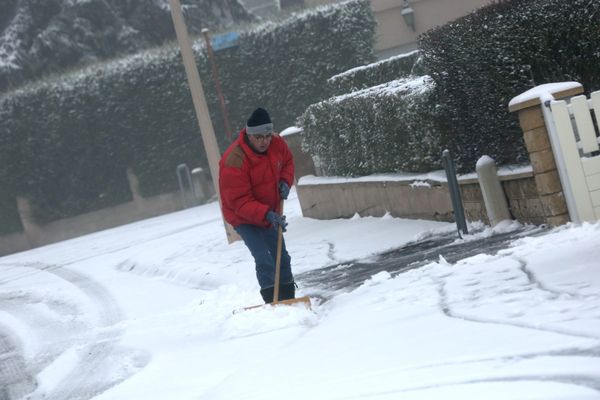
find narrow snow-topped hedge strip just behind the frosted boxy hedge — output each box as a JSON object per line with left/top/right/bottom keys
{"left": 327, "top": 50, "right": 419, "bottom": 96}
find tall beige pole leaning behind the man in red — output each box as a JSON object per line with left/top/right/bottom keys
{"left": 169, "top": 0, "right": 240, "bottom": 243}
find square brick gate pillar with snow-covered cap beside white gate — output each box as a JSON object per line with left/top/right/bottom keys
{"left": 509, "top": 87, "right": 583, "bottom": 226}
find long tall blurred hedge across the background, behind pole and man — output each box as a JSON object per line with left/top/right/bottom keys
{"left": 0, "top": 0, "right": 375, "bottom": 232}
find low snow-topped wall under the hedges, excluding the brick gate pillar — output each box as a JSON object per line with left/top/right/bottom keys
{"left": 297, "top": 172, "right": 545, "bottom": 224}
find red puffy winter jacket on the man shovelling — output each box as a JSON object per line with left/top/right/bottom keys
{"left": 219, "top": 128, "right": 294, "bottom": 228}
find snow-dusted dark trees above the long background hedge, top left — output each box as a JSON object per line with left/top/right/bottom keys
{"left": 0, "top": 0, "right": 255, "bottom": 92}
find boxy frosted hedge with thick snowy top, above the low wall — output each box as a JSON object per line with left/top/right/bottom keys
{"left": 299, "top": 76, "right": 441, "bottom": 176}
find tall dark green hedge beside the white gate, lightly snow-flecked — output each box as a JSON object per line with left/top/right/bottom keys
{"left": 419, "top": 0, "right": 600, "bottom": 171}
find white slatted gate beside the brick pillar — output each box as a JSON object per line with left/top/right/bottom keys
{"left": 543, "top": 91, "right": 600, "bottom": 222}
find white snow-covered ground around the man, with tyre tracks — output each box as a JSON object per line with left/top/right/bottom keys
{"left": 0, "top": 189, "right": 600, "bottom": 400}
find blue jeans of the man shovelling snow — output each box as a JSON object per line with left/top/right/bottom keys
{"left": 235, "top": 224, "right": 294, "bottom": 289}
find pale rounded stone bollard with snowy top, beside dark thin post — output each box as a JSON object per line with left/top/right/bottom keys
{"left": 475, "top": 156, "right": 512, "bottom": 226}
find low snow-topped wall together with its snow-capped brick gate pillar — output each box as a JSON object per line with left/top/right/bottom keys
{"left": 298, "top": 83, "right": 583, "bottom": 225}
